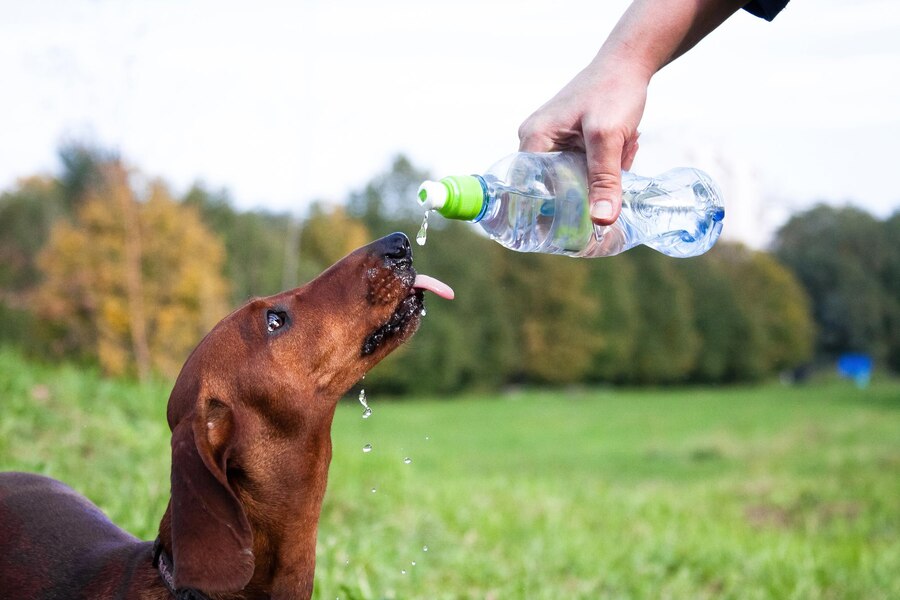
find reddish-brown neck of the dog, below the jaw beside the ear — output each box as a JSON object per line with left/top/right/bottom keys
{"left": 159, "top": 434, "right": 331, "bottom": 600}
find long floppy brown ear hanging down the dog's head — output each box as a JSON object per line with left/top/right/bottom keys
{"left": 171, "top": 400, "right": 254, "bottom": 592}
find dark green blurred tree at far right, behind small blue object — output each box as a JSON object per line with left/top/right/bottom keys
{"left": 775, "top": 205, "right": 892, "bottom": 359}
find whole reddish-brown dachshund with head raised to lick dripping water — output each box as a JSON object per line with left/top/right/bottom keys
{"left": 0, "top": 233, "right": 452, "bottom": 600}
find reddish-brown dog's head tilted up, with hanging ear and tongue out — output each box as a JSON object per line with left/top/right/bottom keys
{"left": 161, "top": 233, "right": 452, "bottom": 592}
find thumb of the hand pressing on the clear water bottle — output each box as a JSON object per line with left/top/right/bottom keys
{"left": 585, "top": 136, "right": 623, "bottom": 225}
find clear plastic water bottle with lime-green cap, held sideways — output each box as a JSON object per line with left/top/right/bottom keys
{"left": 418, "top": 152, "right": 725, "bottom": 258}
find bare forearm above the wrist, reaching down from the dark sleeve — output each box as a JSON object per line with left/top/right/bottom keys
{"left": 594, "top": 0, "right": 748, "bottom": 81}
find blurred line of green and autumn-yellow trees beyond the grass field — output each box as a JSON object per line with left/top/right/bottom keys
{"left": 0, "top": 144, "right": 900, "bottom": 394}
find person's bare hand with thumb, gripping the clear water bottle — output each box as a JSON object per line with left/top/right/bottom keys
{"left": 519, "top": 56, "right": 650, "bottom": 225}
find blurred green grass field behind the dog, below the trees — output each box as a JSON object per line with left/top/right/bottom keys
{"left": 0, "top": 344, "right": 900, "bottom": 600}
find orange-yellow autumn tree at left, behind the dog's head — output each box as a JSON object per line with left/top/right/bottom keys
{"left": 35, "top": 163, "right": 228, "bottom": 376}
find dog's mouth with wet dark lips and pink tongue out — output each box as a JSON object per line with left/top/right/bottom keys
{"left": 361, "top": 255, "right": 454, "bottom": 356}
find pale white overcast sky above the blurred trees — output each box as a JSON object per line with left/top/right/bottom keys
{"left": 0, "top": 0, "right": 900, "bottom": 245}
